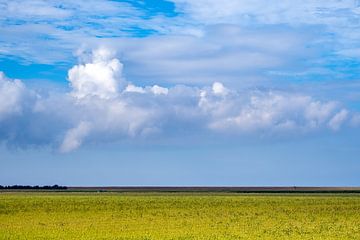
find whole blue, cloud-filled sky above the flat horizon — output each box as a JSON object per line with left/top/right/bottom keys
{"left": 0, "top": 0, "right": 360, "bottom": 186}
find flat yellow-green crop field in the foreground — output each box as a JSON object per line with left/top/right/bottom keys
{"left": 0, "top": 192, "right": 360, "bottom": 240}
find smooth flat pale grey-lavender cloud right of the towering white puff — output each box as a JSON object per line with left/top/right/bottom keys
{"left": 110, "top": 24, "right": 321, "bottom": 85}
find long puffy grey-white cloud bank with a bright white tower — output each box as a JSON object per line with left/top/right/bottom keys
{"left": 0, "top": 48, "right": 357, "bottom": 153}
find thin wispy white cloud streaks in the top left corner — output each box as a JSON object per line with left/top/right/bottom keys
{"left": 0, "top": 0, "right": 140, "bottom": 25}
